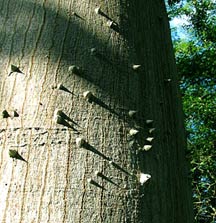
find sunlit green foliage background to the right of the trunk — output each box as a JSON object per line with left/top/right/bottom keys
{"left": 169, "top": 0, "right": 216, "bottom": 223}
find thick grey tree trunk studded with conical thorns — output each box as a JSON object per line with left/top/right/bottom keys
{"left": 0, "top": 0, "right": 192, "bottom": 223}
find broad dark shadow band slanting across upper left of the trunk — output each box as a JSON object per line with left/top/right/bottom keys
{"left": 0, "top": 0, "right": 149, "bottom": 116}
